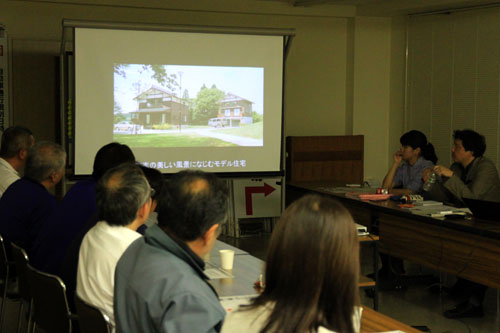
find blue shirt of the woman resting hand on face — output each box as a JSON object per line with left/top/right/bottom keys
{"left": 394, "top": 157, "right": 434, "bottom": 194}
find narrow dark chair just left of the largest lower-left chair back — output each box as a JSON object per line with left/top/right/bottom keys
{"left": 11, "top": 243, "right": 33, "bottom": 332}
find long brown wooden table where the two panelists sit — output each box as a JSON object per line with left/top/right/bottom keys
{"left": 286, "top": 182, "right": 500, "bottom": 289}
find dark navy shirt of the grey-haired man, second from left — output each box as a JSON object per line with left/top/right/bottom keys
{"left": 0, "top": 178, "right": 57, "bottom": 260}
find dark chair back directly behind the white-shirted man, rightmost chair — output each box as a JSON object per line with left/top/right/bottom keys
{"left": 75, "top": 295, "right": 111, "bottom": 333}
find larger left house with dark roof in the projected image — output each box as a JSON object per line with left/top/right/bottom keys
{"left": 131, "top": 85, "right": 190, "bottom": 128}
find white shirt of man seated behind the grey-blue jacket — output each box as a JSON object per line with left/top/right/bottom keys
{"left": 76, "top": 221, "right": 141, "bottom": 331}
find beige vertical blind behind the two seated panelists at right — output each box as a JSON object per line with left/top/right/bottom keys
{"left": 406, "top": 8, "right": 500, "bottom": 168}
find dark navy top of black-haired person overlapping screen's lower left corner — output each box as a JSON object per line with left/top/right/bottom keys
{"left": 30, "top": 179, "right": 96, "bottom": 275}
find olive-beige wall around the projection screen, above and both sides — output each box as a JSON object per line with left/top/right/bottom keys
{"left": 0, "top": 0, "right": 404, "bottom": 182}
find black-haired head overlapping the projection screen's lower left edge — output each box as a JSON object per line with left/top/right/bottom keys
{"left": 92, "top": 142, "right": 135, "bottom": 180}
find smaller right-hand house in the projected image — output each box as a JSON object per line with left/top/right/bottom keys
{"left": 217, "top": 93, "right": 253, "bottom": 127}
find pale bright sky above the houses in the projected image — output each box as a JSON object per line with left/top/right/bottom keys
{"left": 114, "top": 64, "right": 264, "bottom": 114}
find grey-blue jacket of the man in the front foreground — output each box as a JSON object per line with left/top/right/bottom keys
{"left": 114, "top": 225, "right": 226, "bottom": 333}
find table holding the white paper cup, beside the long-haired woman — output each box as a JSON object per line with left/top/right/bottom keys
{"left": 209, "top": 241, "right": 420, "bottom": 333}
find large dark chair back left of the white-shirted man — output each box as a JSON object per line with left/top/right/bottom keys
{"left": 27, "top": 265, "right": 72, "bottom": 333}
